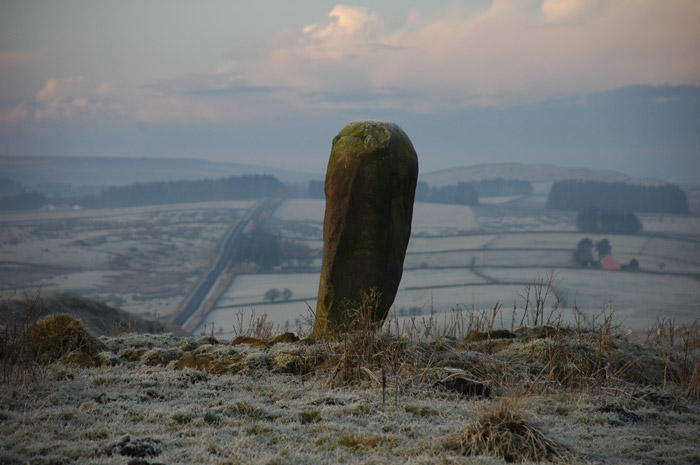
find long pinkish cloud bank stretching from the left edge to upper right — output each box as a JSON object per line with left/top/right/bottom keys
{"left": 5, "top": 0, "right": 700, "bottom": 128}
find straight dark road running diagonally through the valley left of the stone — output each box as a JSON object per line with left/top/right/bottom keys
{"left": 171, "top": 199, "right": 277, "bottom": 327}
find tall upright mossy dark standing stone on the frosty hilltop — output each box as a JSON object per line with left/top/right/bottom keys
{"left": 314, "top": 121, "right": 418, "bottom": 335}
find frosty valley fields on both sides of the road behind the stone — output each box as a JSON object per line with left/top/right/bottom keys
{"left": 0, "top": 196, "right": 700, "bottom": 337}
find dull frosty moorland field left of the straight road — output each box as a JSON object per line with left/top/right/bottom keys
{"left": 0, "top": 202, "right": 254, "bottom": 317}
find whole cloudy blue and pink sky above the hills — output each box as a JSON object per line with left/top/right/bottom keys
{"left": 0, "top": 0, "right": 700, "bottom": 182}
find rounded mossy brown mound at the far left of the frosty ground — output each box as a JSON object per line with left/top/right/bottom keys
{"left": 26, "top": 315, "right": 104, "bottom": 365}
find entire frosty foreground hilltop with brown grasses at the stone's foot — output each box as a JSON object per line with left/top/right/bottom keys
{"left": 0, "top": 289, "right": 700, "bottom": 465}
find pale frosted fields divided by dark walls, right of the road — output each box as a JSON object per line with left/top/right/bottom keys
{"left": 196, "top": 199, "right": 700, "bottom": 335}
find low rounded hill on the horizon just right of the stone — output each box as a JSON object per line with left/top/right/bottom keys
{"left": 420, "top": 163, "right": 665, "bottom": 186}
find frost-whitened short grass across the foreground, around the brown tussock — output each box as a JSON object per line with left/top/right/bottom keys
{"left": 0, "top": 335, "right": 700, "bottom": 465}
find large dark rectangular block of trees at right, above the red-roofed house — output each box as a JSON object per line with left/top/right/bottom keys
{"left": 547, "top": 180, "right": 688, "bottom": 213}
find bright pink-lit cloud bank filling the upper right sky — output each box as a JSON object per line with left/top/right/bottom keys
{"left": 232, "top": 0, "right": 700, "bottom": 111}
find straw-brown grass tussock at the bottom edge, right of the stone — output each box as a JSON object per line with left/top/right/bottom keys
{"left": 459, "top": 401, "right": 564, "bottom": 463}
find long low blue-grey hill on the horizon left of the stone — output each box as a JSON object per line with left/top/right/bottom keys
{"left": 0, "top": 156, "right": 322, "bottom": 187}
